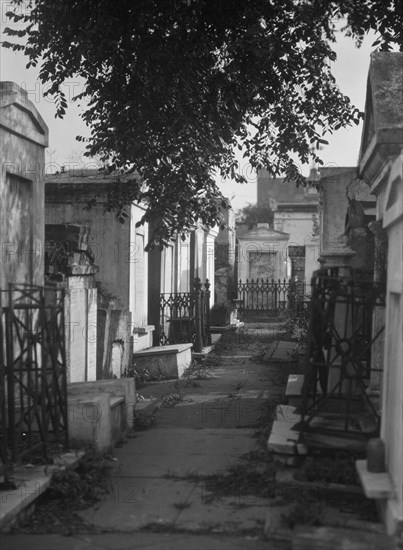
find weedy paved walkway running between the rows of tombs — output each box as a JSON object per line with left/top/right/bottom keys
{"left": 0, "top": 342, "right": 290, "bottom": 550}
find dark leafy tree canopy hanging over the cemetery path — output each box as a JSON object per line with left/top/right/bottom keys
{"left": 3, "top": 0, "right": 403, "bottom": 245}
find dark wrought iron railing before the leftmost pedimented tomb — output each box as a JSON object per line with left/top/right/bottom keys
{"left": 0, "top": 285, "right": 68, "bottom": 488}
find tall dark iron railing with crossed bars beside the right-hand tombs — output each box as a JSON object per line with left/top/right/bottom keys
{"left": 301, "top": 268, "right": 385, "bottom": 435}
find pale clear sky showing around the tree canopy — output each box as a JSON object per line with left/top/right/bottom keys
{"left": 0, "top": 5, "right": 374, "bottom": 209}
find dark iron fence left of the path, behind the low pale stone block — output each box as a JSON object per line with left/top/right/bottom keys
{"left": 158, "top": 278, "right": 211, "bottom": 352}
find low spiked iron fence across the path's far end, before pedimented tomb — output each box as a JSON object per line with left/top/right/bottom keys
{"left": 238, "top": 279, "right": 309, "bottom": 314}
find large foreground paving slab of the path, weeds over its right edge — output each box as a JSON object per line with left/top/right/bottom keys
{"left": 80, "top": 428, "right": 267, "bottom": 532}
